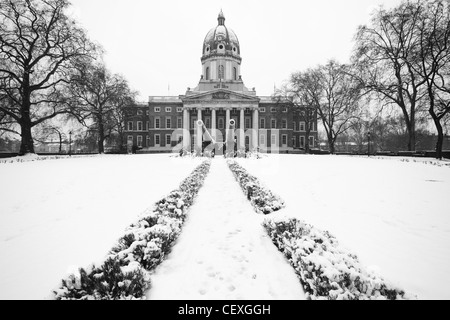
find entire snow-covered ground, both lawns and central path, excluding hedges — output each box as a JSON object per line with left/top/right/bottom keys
{"left": 0, "top": 155, "right": 450, "bottom": 299}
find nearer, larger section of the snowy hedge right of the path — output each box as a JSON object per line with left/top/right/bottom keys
{"left": 263, "top": 218, "right": 412, "bottom": 300}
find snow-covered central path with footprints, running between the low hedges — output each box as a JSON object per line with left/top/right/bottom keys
{"left": 147, "top": 158, "right": 305, "bottom": 300}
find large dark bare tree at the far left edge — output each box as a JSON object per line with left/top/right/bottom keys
{"left": 0, "top": 0, "right": 95, "bottom": 155}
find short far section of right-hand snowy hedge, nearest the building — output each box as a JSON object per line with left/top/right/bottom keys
{"left": 227, "top": 160, "right": 285, "bottom": 214}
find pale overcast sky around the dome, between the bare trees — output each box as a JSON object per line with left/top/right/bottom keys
{"left": 70, "top": 0, "right": 400, "bottom": 102}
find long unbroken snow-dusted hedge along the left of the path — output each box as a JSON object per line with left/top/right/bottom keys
{"left": 54, "top": 160, "right": 211, "bottom": 300}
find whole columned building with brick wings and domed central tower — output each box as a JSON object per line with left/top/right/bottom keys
{"left": 125, "top": 11, "right": 318, "bottom": 152}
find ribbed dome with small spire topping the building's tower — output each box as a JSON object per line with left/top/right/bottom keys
{"left": 203, "top": 10, "right": 241, "bottom": 57}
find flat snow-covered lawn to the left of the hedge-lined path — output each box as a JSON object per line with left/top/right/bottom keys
{"left": 0, "top": 155, "right": 201, "bottom": 299}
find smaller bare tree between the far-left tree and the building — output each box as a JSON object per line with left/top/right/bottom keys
{"left": 70, "top": 64, "right": 135, "bottom": 153}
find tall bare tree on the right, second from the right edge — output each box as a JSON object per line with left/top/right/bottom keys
{"left": 353, "top": 1, "right": 425, "bottom": 151}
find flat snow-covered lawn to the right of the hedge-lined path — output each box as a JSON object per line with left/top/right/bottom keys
{"left": 239, "top": 155, "right": 450, "bottom": 299}
